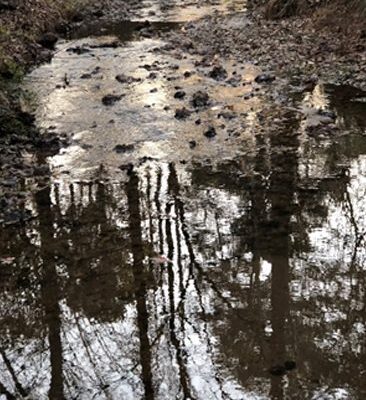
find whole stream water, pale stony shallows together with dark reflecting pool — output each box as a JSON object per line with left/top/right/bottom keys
{"left": 0, "top": 2, "right": 366, "bottom": 400}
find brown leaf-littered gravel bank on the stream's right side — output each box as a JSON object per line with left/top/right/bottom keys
{"left": 170, "top": 9, "right": 366, "bottom": 89}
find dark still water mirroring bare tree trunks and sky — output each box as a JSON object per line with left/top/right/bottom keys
{"left": 0, "top": 94, "right": 366, "bottom": 399}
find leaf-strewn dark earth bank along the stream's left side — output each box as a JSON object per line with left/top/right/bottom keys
{"left": 0, "top": 0, "right": 146, "bottom": 225}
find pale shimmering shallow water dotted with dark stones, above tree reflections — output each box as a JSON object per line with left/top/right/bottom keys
{"left": 25, "top": 36, "right": 260, "bottom": 180}
